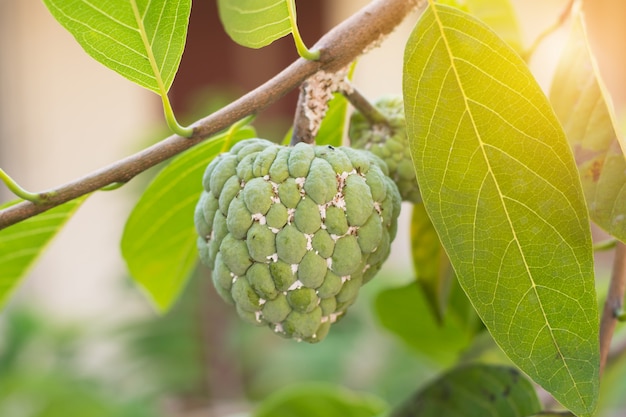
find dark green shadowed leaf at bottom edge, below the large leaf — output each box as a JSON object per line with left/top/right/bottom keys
{"left": 390, "top": 365, "right": 541, "bottom": 417}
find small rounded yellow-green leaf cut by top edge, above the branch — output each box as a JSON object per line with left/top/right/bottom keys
{"left": 217, "top": 0, "right": 291, "bottom": 48}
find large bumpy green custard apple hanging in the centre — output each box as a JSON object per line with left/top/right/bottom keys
{"left": 195, "top": 139, "right": 401, "bottom": 342}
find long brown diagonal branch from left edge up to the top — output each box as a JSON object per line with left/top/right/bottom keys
{"left": 0, "top": 0, "right": 426, "bottom": 230}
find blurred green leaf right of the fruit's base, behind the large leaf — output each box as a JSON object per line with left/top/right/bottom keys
{"left": 375, "top": 284, "right": 476, "bottom": 365}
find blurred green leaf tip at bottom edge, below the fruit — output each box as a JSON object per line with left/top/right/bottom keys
{"left": 252, "top": 382, "right": 387, "bottom": 417}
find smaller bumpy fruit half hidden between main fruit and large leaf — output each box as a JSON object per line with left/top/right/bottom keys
{"left": 349, "top": 97, "right": 422, "bottom": 203}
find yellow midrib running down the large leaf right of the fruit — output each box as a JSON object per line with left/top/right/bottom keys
{"left": 429, "top": 0, "right": 586, "bottom": 405}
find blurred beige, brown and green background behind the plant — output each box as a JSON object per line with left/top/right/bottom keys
{"left": 0, "top": 0, "right": 626, "bottom": 417}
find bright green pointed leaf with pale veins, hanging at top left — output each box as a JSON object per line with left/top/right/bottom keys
{"left": 43, "top": 0, "right": 191, "bottom": 95}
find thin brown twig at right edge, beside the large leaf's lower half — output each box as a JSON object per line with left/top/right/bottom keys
{"left": 600, "top": 242, "right": 626, "bottom": 375}
